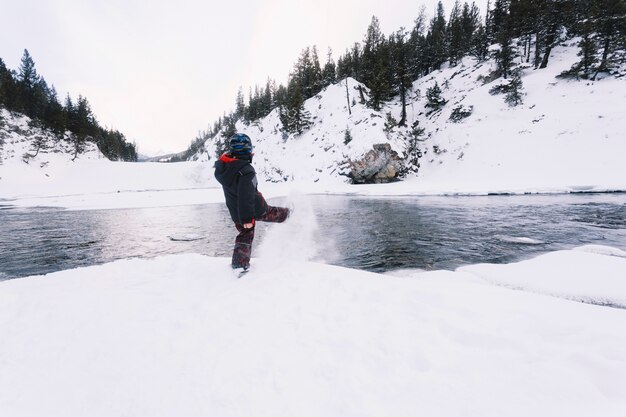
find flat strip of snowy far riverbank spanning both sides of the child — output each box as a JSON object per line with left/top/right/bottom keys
{"left": 0, "top": 160, "right": 626, "bottom": 209}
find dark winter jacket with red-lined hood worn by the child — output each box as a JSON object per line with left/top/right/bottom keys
{"left": 215, "top": 154, "right": 267, "bottom": 224}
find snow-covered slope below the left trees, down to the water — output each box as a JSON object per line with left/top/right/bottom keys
{"left": 0, "top": 108, "right": 214, "bottom": 208}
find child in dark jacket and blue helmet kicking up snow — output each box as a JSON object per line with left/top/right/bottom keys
{"left": 215, "top": 133, "right": 289, "bottom": 270}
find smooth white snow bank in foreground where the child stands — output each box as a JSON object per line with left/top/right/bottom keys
{"left": 0, "top": 245, "right": 626, "bottom": 417}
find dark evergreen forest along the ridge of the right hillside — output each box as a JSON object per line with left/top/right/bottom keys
{"left": 175, "top": 0, "right": 626, "bottom": 160}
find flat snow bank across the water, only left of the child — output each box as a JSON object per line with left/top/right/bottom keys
{"left": 0, "top": 160, "right": 223, "bottom": 209}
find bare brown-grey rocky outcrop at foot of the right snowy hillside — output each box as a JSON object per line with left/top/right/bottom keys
{"left": 347, "top": 143, "right": 405, "bottom": 184}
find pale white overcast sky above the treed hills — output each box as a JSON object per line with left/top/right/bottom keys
{"left": 0, "top": 0, "right": 458, "bottom": 153}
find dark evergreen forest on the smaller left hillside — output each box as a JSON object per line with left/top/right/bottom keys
{"left": 0, "top": 50, "right": 137, "bottom": 161}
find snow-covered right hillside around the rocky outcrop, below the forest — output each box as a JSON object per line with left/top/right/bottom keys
{"left": 192, "top": 41, "right": 626, "bottom": 193}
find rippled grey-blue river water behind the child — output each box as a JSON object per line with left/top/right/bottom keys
{"left": 0, "top": 194, "right": 626, "bottom": 279}
